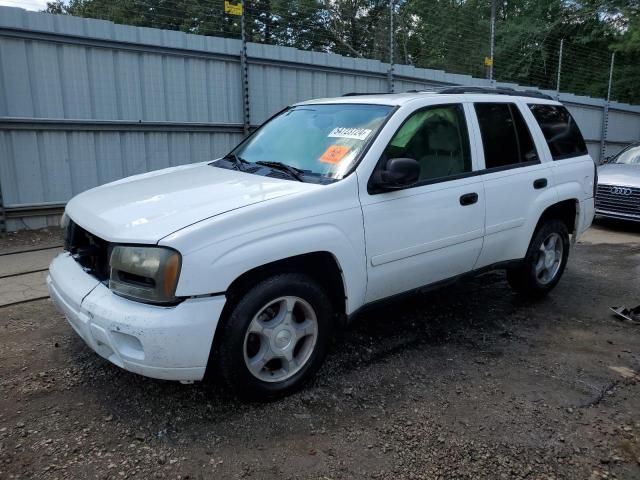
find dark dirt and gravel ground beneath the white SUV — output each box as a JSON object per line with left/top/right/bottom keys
{"left": 0, "top": 219, "right": 640, "bottom": 479}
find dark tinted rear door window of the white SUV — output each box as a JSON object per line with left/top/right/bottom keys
{"left": 475, "top": 103, "right": 538, "bottom": 168}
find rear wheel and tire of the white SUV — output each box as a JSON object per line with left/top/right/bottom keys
{"left": 507, "top": 218, "right": 570, "bottom": 298}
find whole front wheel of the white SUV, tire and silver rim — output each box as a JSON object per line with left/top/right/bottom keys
{"left": 217, "top": 273, "right": 332, "bottom": 401}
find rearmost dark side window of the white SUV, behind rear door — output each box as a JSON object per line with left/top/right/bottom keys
{"left": 529, "top": 105, "right": 588, "bottom": 160}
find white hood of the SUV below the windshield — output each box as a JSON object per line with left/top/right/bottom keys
{"left": 66, "top": 162, "right": 321, "bottom": 243}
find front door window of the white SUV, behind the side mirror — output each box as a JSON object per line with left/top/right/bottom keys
{"left": 383, "top": 105, "right": 471, "bottom": 181}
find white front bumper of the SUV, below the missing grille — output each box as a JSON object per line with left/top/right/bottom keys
{"left": 47, "top": 253, "right": 225, "bottom": 381}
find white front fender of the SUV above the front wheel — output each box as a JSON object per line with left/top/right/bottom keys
{"left": 159, "top": 175, "right": 367, "bottom": 313}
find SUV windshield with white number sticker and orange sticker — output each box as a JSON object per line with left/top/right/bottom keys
{"left": 231, "top": 104, "right": 392, "bottom": 179}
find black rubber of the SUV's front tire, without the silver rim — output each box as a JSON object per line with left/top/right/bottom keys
{"left": 217, "top": 273, "right": 332, "bottom": 400}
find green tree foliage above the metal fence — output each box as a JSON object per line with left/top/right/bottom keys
{"left": 47, "top": 0, "right": 640, "bottom": 103}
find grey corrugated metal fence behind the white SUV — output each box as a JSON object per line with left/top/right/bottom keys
{"left": 0, "top": 7, "right": 640, "bottom": 230}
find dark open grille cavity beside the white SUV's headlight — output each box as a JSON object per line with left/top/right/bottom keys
{"left": 64, "top": 220, "right": 112, "bottom": 281}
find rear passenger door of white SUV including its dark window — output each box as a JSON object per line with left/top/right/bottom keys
{"left": 473, "top": 99, "right": 555, "bottom": 268}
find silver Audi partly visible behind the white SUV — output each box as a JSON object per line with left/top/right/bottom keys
{"left": 596, "top": 143, "right": 640, "bottom": 222}
